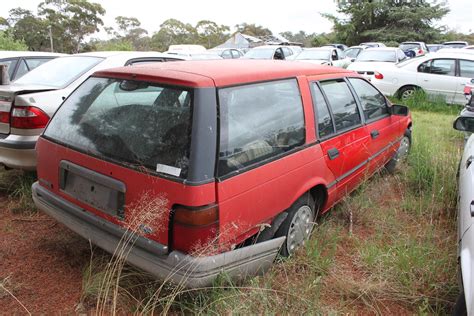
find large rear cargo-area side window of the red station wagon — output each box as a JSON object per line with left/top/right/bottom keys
{"left": 218, "top": 79, "right": 305, "bottom": 176}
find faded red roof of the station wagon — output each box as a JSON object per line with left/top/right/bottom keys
{"left": 95, "top": 59, "right": 353, "bottom": 87}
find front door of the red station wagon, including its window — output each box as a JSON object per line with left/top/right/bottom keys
{"left": 348, "top": 78, "right": 400, "bottom": 171}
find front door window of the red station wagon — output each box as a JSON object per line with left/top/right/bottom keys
{"left": 349, "top": 78, "right": 389, "bottom": 120}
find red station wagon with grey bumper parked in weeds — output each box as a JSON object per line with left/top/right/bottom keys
{"left": 33, "top": 60, "right": 412, "bottom": 287}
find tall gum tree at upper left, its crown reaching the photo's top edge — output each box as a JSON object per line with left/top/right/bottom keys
{"left": 38, "top": 0, "right": 105, "bottom": 53}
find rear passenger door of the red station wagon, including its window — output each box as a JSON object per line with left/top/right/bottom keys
{"left": 312, "top": 78, "right": 370, "bottom": 198}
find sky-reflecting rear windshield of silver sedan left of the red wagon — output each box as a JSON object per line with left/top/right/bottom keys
{"left": 15, "top": 56, "right": 103, "bottom": 89}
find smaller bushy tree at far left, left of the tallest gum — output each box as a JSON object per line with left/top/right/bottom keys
{"left": 7, "top": 8, "right": 51, "bottom": 51}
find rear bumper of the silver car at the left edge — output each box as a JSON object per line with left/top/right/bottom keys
{"left": 0, "top": 135, "right": 38, "bottom": 170}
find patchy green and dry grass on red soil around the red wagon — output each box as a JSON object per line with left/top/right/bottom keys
{"left": 0, "top": 96, "right": 463, "bottom": 314}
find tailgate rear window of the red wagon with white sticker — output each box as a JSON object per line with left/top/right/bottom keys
{"left": 44, "top": 77, "right": 192, "bottom": 178}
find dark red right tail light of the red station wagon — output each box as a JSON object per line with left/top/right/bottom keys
{"left": 171, "top": 204, "right": 219, "bottom": 253}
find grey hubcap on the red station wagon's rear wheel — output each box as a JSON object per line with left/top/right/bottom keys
{"left": 286, "top": 205, "right": 313, "bottom": 255}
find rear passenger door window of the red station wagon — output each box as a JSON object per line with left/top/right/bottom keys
{"left": 320, "top": 79, "right": 361, "bottom": 132}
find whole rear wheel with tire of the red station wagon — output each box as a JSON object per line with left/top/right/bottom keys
{"left": 275, "top": 193, "right": 316, "bottom": 257}
